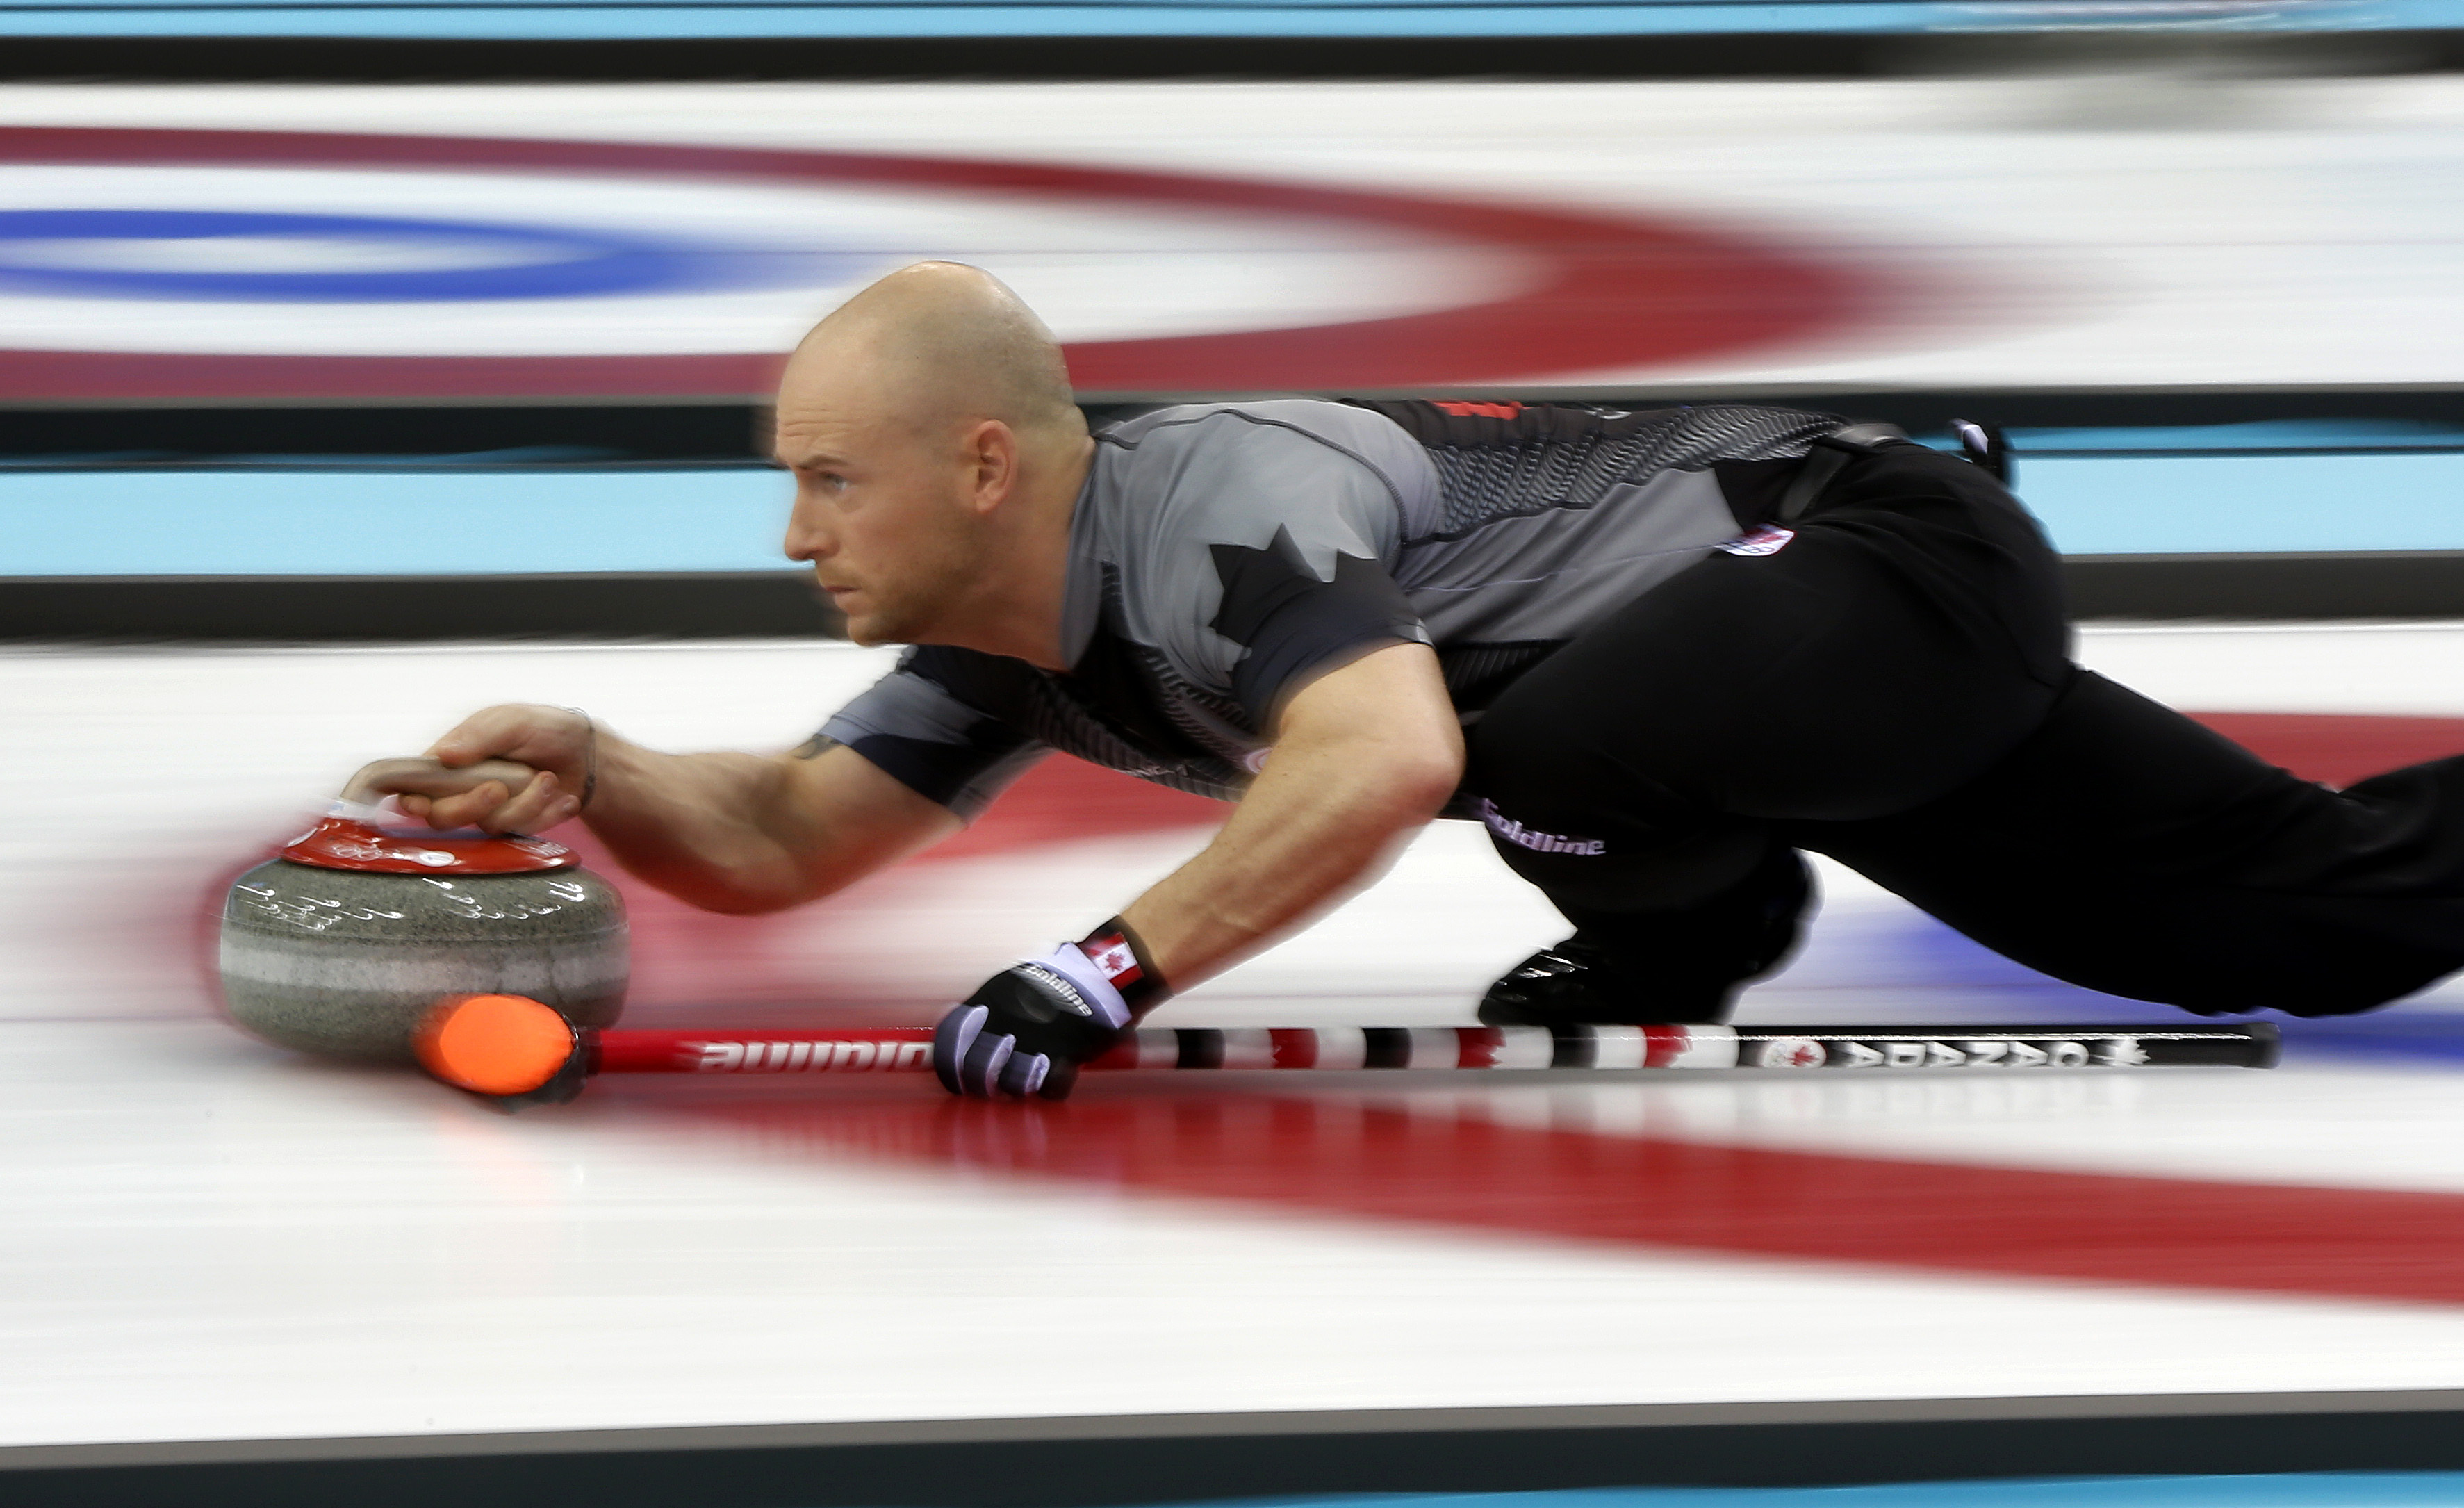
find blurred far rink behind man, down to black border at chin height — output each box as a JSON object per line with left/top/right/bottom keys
{"left": 0, "top": 0, "right": 2464, "bottom": 641}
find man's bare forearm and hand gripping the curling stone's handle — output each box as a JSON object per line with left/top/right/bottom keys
{"left": 402, "top": 705, "right": 958, "bottom": 912}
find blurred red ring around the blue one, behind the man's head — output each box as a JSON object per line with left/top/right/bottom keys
{"left": 0, "top": 126, "right": 1892, "bottom": 402}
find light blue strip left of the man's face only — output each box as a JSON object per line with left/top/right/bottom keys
{"left": 0, "top": 468, "right": 791, "bottom": 577}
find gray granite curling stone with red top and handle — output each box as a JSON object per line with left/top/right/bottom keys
{"left": 222, "top": 759, "right": 628, "bottom": 1062}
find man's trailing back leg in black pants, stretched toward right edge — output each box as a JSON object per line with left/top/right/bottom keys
{"left": 1787, "top": 673, "right": 2464, "bottom": 1015}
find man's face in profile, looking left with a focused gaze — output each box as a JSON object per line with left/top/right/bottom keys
{"left": 776, "top": 350, "right": 983, "bottom": 646}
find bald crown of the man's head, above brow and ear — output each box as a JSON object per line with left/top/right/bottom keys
{"left": 781, "top": 261, "right": 1087, "bottom": 446}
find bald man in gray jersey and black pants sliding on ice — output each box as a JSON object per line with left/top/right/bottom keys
{"left": 409, "top": 263, "right": 2464, "bottom": 1099}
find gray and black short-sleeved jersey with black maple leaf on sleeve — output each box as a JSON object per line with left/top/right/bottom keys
{"left": 821, "top": 399, "right": 1846, "bottom": 818}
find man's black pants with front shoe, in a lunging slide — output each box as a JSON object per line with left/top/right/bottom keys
{"left": 1468, "top": 446, "right": 2464, "bottom": 1020}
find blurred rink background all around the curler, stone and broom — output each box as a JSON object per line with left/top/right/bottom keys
{"left": 14, "top": 11, "right": 2464, "bottom": 1508}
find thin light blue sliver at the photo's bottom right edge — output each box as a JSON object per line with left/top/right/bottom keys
{"left": 1118, "top": 1471, "right": 2464, "bottom": 1508}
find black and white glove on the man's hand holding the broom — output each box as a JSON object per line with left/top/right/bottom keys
{"left": 931, "top": 921, "right": 1165, "bottom": 1099}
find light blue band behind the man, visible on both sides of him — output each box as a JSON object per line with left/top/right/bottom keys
{"left": 14, "top": 451, "right": 2464, "bottom": 577}
